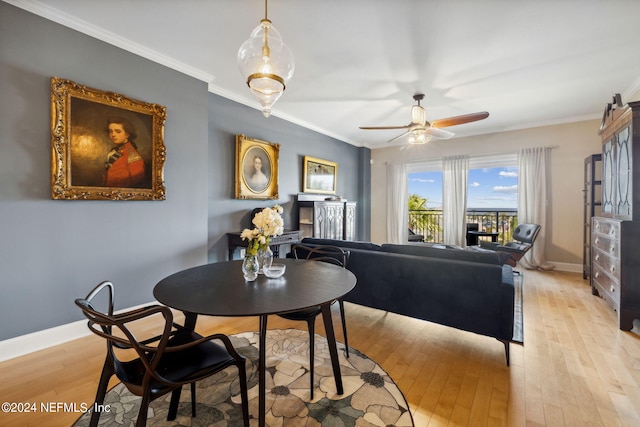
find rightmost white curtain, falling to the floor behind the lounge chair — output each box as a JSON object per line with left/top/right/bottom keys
{"left": 518, "top": 147, "right": 555, "bottom": 270}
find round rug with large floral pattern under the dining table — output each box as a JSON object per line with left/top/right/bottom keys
{"left": 74, "top": 329, "right": 414, "bottom": 427}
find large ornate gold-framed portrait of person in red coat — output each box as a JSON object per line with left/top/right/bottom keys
{"left": 51, "top": 77, "right": 167, "bottom": 200}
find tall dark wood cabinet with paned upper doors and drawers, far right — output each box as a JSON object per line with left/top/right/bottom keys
{"left": 591, "top": 98, "right": 640, "bottom": 330}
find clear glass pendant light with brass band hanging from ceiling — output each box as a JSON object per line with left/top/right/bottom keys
{"left": 238, "top": 0, "right": 295, "bottom": 117}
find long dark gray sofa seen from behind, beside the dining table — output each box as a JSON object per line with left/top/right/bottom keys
{"left": 302, "top": 238, "right": 514, "bottom": 365}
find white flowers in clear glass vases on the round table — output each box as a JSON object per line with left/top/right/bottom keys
{"left": 240, "top": 205, "right": 284, "bottom": 281}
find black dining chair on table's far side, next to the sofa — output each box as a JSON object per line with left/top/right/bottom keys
{"left": 278, "top": 245, "right": 351, "bottom": 400}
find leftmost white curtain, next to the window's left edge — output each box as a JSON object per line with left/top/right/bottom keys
{"left": 387, "top": 163, "right": 409, "bottom": 243}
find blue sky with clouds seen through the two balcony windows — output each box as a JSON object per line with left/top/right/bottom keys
{"left": 408, "top": 167, "right": 518, "bottom": 209}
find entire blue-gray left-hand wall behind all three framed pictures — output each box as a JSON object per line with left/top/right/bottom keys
{"left": 0, "top": 2, "right": 370, "bottom": 340}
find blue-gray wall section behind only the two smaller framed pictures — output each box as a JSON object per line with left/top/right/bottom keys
{"left": 209, "top": 94, "right": 371, "bottom": 262}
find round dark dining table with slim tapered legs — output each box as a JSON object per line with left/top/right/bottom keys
{"left": 153, "top": 258, "right": 356, "bottom": 426}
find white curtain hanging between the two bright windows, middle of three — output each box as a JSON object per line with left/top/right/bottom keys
{"left": 442, "top": 155, "right": 469, "bottom": 247}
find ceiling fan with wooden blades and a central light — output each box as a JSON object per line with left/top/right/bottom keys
{"left": 360, "top": 93, "right": 489, "bottom": 144}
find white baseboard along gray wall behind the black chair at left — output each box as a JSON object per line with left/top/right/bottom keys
{"left": 0, "top": 303, "right": 152, "bottom": 362}
